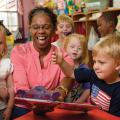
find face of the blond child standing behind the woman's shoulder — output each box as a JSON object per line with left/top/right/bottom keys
{"left": 56, "top": 21, "right": 73, "bottom": 37}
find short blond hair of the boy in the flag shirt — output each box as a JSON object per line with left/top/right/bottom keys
{"left": 92, "top": 34, "right": 120, "bottom": 60}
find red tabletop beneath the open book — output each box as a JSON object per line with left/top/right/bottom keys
{"left": 15, "top": 109, "right": 120, "bottom": 120}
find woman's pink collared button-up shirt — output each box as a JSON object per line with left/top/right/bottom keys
{"left": 11, "top": 42, "right": 73, "bottom": 91}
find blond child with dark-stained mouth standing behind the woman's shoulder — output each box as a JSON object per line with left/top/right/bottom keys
{"left": 52, "top": 14, "right": 74, "bottom": 47}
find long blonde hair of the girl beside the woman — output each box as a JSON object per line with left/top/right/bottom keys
{"left": 64, "top": 33, "right": 89, "bottom": 64}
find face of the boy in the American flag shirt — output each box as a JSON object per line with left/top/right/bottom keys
{"left": 93, "top": 51, "right": 118, "bottom": 83}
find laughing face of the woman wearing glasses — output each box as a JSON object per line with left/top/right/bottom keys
{"left": 30, "top": 14, "right": 54, "bottom": 51}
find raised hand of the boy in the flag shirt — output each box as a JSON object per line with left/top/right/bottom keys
{"left": 52, "top": 47, "right": 63, "bottom": 65}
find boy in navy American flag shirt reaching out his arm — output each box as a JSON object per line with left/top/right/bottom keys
{"left": 52, "top": 35, "right": 120, "bottom": 116}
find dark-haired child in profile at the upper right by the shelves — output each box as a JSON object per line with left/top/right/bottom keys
{"left": 97, "top": 12, "right": 120, "bottom": 39}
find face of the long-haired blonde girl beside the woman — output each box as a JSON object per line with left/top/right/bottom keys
{"left": 66, "top": 37, "right": 82, "bottom": 61}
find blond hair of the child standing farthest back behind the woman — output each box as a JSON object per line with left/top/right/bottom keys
{"left": 57, "top": 14, "right": 74, "bottom": 31}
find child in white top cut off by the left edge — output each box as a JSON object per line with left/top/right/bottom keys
{"left": 0, "top": 27, "right": 14, "bottom": 120}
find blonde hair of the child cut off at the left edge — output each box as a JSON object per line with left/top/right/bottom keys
{"left": 0, "top": 25, "right": 8, "bottom": 59}
